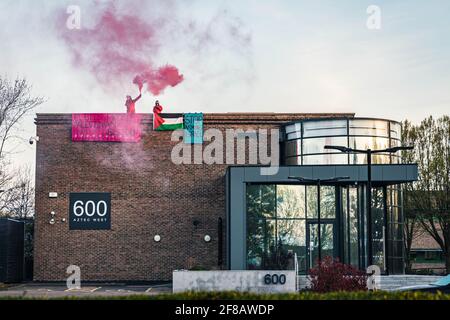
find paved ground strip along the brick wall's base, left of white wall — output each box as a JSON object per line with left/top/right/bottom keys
{"left": 0, "top": 283, "right": 172, "bottom": 298}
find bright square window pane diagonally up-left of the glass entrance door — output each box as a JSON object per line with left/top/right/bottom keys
{"left": 277, "top": 185, "right": 305, "bottom": 218}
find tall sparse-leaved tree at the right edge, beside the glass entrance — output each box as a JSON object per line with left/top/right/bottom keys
{"left": 403, "top": 116, "right": 450, "bottom": 273}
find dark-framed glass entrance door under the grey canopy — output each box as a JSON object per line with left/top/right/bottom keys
{"left": 306, "top": 221, "right": 336, "bottom": 269}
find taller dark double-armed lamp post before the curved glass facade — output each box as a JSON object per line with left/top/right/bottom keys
{"left": 324, "top": 145, "right": 414, "bottom": 266}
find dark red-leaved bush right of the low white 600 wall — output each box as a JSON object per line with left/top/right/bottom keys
{"left": 309, "top": 257, "right": 367, "bottom": 292}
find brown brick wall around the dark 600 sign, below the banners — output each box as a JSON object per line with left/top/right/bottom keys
{"left": 34, "top": 113, "right": 353, "bottom": 281}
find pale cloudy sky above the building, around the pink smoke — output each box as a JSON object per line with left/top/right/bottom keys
{"left": 0, "top": 0, "right": 450, "bottom": 171}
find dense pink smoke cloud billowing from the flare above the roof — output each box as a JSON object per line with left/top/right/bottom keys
{"left": 58, "top": 4, "right": 183, "bottom": 95}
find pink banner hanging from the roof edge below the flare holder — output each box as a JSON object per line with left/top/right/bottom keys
{"left": 72, "top": 113, "right": 142, "bottom": 142}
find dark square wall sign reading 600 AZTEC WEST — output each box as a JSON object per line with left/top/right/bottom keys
{"left": 69, "top": 192, "right": 111, "bottom": 230}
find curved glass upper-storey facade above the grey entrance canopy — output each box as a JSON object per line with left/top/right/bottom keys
{"left": 282, "top": 118, "right": 401, "bottom": 165}
